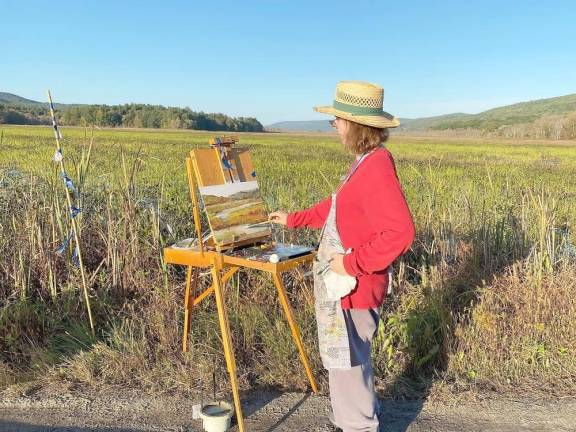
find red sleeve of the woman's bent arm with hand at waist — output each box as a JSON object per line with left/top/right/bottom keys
{"left": 344, "top": 161, "right": 415, "bottom": 277}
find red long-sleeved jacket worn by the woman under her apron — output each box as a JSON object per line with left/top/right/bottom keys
{"left": 287, "top": 148, "right": 414, "bottom": 309}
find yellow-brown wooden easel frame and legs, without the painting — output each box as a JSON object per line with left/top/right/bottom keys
{"left": 164, "top": 137, "right": 318, "bottom": 432}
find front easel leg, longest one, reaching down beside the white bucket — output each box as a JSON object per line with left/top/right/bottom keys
{"left": 212, "top": 266, "right": 244, "bottom": 432}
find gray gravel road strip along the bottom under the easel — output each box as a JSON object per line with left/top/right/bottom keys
{"left": 0, "top": 391, "right": 576, "bottom": 432}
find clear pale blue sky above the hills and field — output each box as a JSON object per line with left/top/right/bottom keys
{"left": 0, "top": 0, "right": 576, "bottom": 125}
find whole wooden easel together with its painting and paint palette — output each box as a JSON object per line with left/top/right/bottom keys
{"left": 164, "top": 137, "right": 318, "bottom": 432}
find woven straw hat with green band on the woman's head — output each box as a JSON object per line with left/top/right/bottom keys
{"left": 314, "top": 81, "right": 400, "bottom": 129}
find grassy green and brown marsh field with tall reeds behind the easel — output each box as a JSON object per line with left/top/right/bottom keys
{"left": 0, "top": 127, "right": 576, "bottom": 396}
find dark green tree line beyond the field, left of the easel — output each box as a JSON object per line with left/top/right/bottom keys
{"left": 0, "top": 104, "right": 264, "bottom": 132}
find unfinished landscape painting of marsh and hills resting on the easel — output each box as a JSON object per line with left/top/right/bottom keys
{"left": 200, "top": 181, "right": 272, "bottom": 245}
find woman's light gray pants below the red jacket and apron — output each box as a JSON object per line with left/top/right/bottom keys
{"left": 328, "top": 309, "right": 379, "bottom": 432}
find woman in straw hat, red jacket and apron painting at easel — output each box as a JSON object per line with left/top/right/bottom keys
{"left": 270, "top": 81, "right": 414, "bottom": 432}
